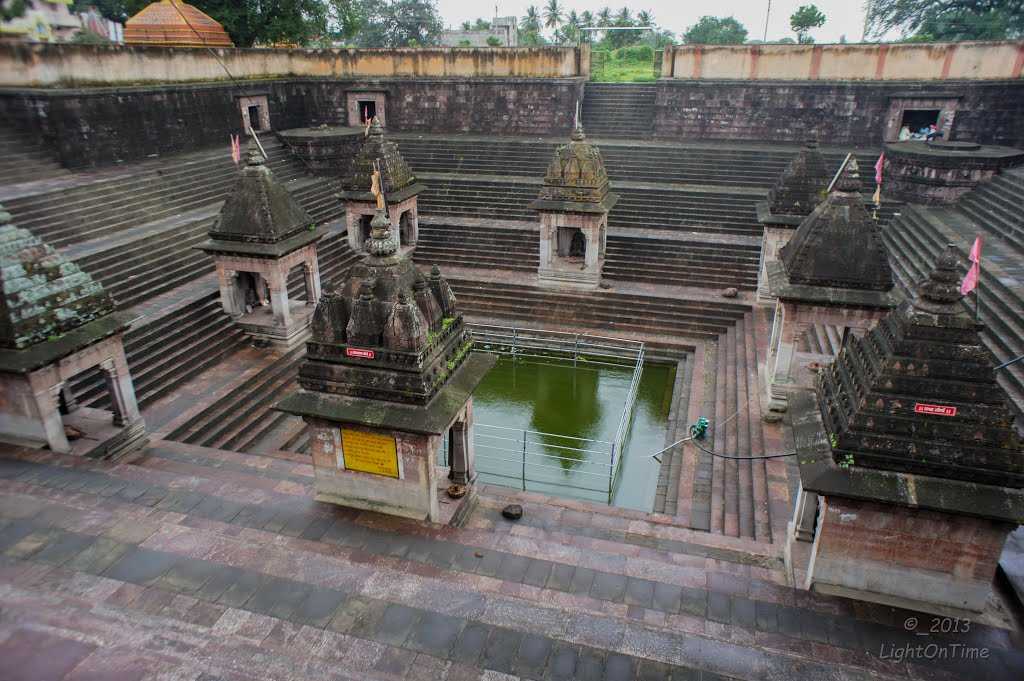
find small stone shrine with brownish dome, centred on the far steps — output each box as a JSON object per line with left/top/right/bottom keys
{"left": 529, "top": 123, "right": 618, "bottom": 288}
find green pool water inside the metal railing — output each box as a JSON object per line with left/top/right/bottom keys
{"left": 473, "top": 355, "right": 676, "bottom": 511}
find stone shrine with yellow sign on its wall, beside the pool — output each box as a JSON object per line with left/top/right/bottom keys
{"left": 278, "top": 189, "right": 494, "bottom": 522}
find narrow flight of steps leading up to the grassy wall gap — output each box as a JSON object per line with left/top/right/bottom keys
{"left": 582, "top": 83, "right": 657, "bottom": 139}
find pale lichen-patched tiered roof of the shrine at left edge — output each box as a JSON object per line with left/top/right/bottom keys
{"left": 0, "top": 206, "right": 114, "bottom": 350}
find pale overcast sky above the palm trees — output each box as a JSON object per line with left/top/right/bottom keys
{"left": 437, "top": 0, "right": 897, "bottom": 43}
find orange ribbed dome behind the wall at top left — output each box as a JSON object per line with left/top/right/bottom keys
{"left": 125, "top": 0, "right": 234, "bottom": 47}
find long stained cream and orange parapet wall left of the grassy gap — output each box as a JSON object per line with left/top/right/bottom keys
{"left": 0, "top": 43, "right": 580, "bottom": 87}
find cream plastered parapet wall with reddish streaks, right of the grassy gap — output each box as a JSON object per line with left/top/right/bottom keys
{"left": 662, "top": 41, "right": 1024, "bottom": 81}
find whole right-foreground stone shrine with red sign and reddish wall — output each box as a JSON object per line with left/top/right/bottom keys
{"left": 791, "top": 245, "right": 1024, "bottom": 613}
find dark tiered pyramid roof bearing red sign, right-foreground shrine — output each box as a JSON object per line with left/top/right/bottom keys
{"left": 818, "top": 245, "right": 1024, "bottom": 487}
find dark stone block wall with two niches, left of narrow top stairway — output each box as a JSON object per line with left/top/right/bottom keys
{"left": 0, "top": 78, "right": 582, "bottom": 168}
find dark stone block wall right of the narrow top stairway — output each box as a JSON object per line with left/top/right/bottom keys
{"left": 654, "top": 79, "right": 1024, "bottom": 148}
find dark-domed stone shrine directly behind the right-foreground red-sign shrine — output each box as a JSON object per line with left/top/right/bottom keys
{"left": 767, "top": 156, "right": 897, "bottom": 418}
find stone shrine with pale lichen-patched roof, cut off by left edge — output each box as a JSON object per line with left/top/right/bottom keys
{"left": 0, "top": 206, "right": 146, "bottom": 459}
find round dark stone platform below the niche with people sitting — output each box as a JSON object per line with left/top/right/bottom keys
{"left": 884, "top": 139, "right": 1024, "bottom": 204}
